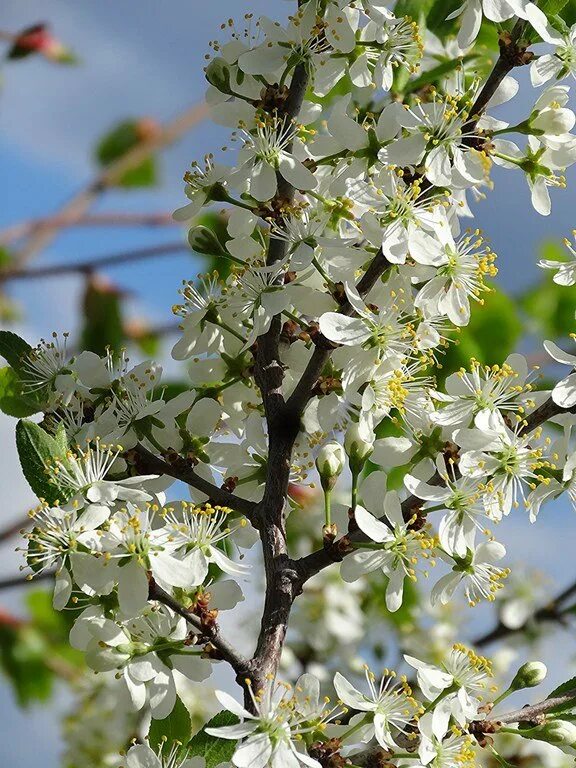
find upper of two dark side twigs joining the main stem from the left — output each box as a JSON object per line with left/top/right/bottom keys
{"left": 132, "top": 445, "right": 256, "bottom": 520}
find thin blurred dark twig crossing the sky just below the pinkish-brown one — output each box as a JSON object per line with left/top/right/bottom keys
{"left": 0, "top": 240, "right": 190, "bottom": 283}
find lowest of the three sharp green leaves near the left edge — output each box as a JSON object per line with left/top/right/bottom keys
{"left": 16, "top": 420, "right": 70, "bottom": 504}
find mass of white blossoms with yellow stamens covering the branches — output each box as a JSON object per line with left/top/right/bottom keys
{"left": 3, "top": 0, "right": 576, "bottom": 768}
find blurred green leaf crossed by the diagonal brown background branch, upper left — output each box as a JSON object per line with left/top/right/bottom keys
{"left": 95, "top": 120, "right": 158, "bottom": 188}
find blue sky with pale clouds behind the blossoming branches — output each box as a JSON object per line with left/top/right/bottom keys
{"left": 0, "top": 0, "right": 576, "bottom": 768}
